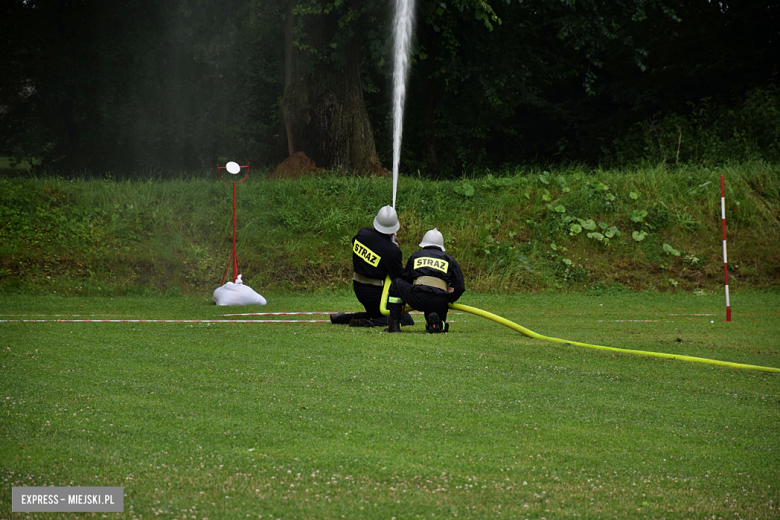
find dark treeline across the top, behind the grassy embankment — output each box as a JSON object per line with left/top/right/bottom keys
{"left": 0, "top": 0, "right": 780, "bottom": 177}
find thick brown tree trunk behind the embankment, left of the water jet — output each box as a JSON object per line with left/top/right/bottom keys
{"left": 281, "top": 0, "right": 384, "bottom": 174}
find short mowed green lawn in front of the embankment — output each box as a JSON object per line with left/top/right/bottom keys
{"left": 0, "top": 291, "right": 780, "bottom": 520}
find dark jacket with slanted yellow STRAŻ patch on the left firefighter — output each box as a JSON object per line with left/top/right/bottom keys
{"left": 352, "top": 227, "right": 404, "bottom": 281}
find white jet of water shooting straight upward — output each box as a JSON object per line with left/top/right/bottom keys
{"left": 393, "top": 0, "right": 414, "bottom": 208}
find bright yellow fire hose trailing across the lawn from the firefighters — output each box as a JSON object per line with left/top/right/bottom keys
{"left": 379, "top": 276, "right": 780, "bottom": 373}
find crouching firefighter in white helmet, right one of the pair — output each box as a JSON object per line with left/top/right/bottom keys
{"left": 385, "top": 228, "right": 466, "bottom": 333}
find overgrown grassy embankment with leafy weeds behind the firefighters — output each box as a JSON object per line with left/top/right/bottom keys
{"left": 0, "top": 163, "right": 780, "bottom": 295}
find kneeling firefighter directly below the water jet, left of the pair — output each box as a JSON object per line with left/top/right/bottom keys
{"left": 330, "top": 206, "right": 414, "bottom": 327}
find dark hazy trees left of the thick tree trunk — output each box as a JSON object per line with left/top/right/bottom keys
{"left": 0, "top": 0, "right": 283, "bottom": 172}
